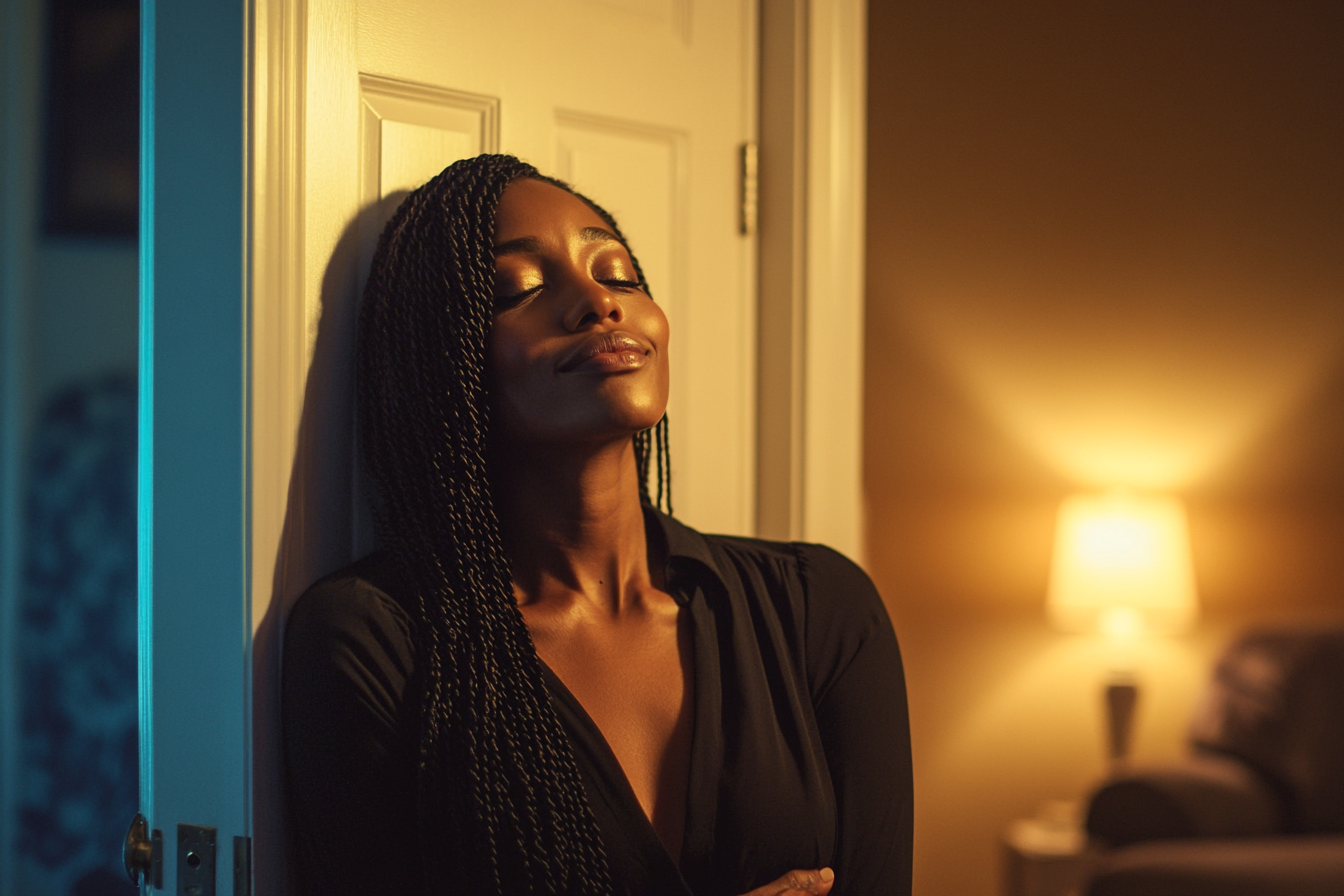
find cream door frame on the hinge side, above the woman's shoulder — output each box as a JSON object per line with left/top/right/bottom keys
{"left": 757, "top": 0, "right": 868, "bottom": 553}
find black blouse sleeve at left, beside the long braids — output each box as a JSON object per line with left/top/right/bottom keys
{"left": 281, "top": 578, "right": 423, "bottom": 896}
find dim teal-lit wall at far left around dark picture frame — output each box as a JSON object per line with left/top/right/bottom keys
{"left": 0, "top": 0, "right": 138, "bottom": 893}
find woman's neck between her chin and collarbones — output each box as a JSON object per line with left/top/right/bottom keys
{"left": 491, "top": 438, "right": 653, "bottom": 615}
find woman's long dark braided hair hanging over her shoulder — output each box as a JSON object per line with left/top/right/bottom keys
{"left": 356, "top": 154, "right": 671, "bottom": 895}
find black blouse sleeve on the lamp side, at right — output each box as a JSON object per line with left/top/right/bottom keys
{"left": 798, "top": 547, "right": 914, "bottom": 896}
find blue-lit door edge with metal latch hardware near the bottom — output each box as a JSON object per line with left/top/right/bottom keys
{"left": 143, "top": 0, "right": 251, "bottom": 892}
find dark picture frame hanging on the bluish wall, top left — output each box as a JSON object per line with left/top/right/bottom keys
{"left": 42, "top": 0, "right": 140, "bottom": 239}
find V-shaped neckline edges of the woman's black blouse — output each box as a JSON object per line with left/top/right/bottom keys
{"left": 540, "top": 577, "right": 723, "bottom": 895}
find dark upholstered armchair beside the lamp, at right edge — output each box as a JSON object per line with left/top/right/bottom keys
{"left": 1086, "top": 629, "right": 1344, "bottom": 896}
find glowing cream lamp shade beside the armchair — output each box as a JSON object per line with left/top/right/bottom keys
{"left": 1048, "top": 492, "right": 1198, "bottom": 634}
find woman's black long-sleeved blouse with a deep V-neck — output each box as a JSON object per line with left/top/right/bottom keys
{"left": 282, "top": 510, "right": 913, "bottom": 896}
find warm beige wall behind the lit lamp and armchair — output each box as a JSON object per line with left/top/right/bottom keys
{"left": 866, "top": 0, "right": 1344, "bottom": 896}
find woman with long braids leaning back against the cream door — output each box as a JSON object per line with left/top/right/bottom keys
{"left": 284, "top": 156, "right": 911, "bottom": 896}
